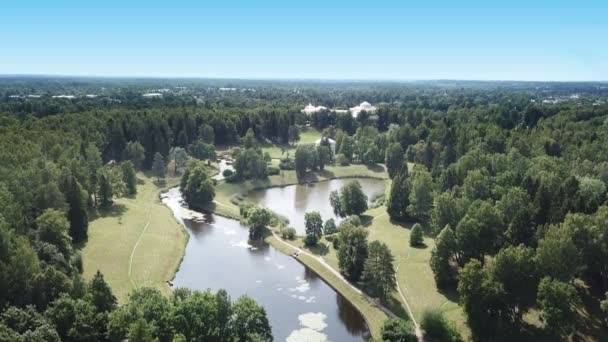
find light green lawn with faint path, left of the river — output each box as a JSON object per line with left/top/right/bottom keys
{"left": 81, "top": 173, "right": 188, "bottom": 303}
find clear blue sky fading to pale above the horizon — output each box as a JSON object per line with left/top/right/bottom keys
{"left": 0, "top": 0, "right": 608, "bottom": 81}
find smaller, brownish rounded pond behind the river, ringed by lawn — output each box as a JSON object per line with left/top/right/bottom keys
{"left": 247, "top": 178, "right": 385, "bottom": 235}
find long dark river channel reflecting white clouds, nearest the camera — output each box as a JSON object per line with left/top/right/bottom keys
{"left": 163, "top": 181, "right": 380, "bottom": 342}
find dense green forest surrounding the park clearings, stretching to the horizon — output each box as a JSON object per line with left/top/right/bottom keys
{"left": 0, "top": 77, "right": 608, "bottom": 341}
